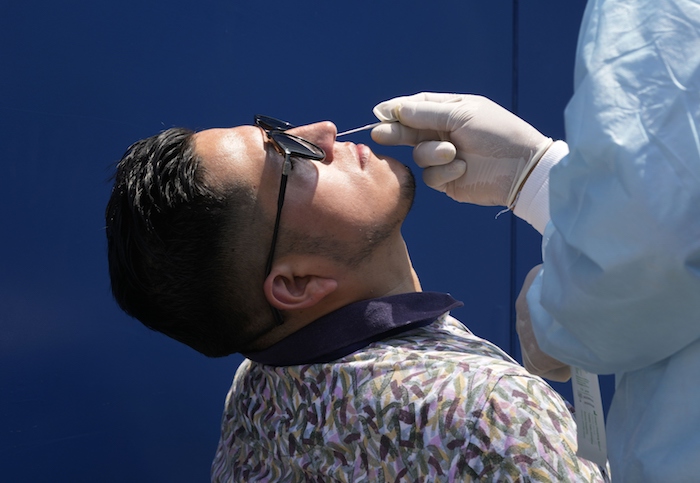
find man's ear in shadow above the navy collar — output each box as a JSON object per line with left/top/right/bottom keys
{"left": 263, "top": 266, "right": 338, "bottom": 310}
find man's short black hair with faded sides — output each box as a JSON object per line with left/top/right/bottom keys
{"left": 105, "top": 128, "right": 272, "bottom": 357}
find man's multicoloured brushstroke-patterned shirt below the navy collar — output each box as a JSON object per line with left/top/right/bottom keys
{"left": 212, "top": 294, "right": 604, "bottom": 482}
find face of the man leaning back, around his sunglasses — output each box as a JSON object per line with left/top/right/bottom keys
{"left": 195, "top": 122, "right": 414, "bottom": 266}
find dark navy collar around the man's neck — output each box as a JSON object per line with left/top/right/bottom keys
{"left": 243, "top": 292, "right": 463, "bottom": 366}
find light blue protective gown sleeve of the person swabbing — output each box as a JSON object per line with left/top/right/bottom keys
{"left": 528, "top": 0, "right": 700, "bottom": 374}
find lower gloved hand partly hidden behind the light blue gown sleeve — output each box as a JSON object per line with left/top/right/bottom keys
{"left": 515, "top": 264, "right": 571, "bottom": 382}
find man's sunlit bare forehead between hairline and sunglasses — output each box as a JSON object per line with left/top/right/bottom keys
{"left": 194, "top": 126, "right": 265, "bottom": 188}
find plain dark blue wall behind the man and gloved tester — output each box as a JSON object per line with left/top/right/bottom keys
{"left": 0, "top": 0, "right": 610, "bottom": 482}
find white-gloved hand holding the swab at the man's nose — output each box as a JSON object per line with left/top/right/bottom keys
{"left": 372, "top": 92, "right": 552, "bottom": 208}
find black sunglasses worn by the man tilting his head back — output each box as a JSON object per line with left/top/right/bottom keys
{"left": 255, "top": 114, "right": 326, "bottom": 325}
